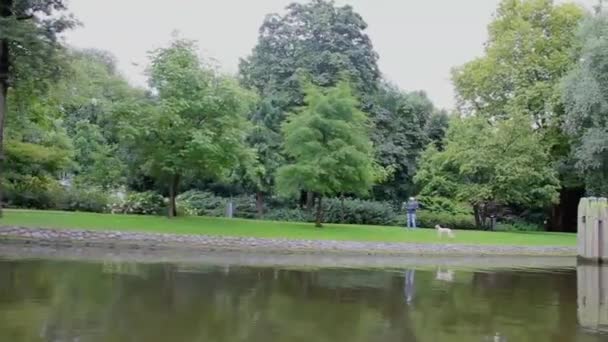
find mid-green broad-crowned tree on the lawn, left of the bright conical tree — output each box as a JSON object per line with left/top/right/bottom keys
{"left": 133, "top": 40, "right": 253, "bottom": 217}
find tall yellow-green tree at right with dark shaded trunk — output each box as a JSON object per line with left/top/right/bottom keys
{"left": 452, "top": 0, "right": 585, "bottom": 230}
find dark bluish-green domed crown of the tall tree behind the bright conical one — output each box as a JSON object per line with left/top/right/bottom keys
{"left": 240, "top": 0, "right": 380, "bottom": 106}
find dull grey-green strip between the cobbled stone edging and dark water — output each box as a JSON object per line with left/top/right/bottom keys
{"left": 0, "top": 241, "right": 577, "bottom": 270}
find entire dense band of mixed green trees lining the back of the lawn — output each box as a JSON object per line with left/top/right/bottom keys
{"left": 0, "top": 0, "right": 608, "bottom": 231}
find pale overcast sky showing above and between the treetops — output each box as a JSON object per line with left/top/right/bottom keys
{"left": 67, "top": 0, "right": 597, "bottom": 108}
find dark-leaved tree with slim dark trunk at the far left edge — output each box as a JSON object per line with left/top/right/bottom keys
{"left": 0, "top": 0, "right": 75, "bottom": 215}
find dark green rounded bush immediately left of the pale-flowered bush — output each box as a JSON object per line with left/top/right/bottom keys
{"left": 58, "top": 187, "right": 110, "bottom": 213}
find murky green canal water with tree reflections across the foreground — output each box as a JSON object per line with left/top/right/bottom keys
{"left": 0, "top": 259, "right": 608, "bottom": 342}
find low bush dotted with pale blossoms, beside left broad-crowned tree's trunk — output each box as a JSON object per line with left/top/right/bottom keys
{"left": 110, "top": 191, "right": 166, "bottom": 215}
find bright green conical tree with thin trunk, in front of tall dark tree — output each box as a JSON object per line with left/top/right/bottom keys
{"left": 277, "top": 82, "right": 376, "bottom": 227}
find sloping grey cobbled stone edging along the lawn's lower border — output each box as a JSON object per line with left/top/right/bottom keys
{"left": 0, "top": 227, "right": 576, "bottom": 256}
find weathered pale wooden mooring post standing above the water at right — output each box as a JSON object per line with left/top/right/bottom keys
{"left": 577, "top": 197, "right": 608, "bottom": 263}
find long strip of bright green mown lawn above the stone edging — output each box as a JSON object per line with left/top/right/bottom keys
{"left": 0, "top": 210, "right": 576, "bottom": 246}
